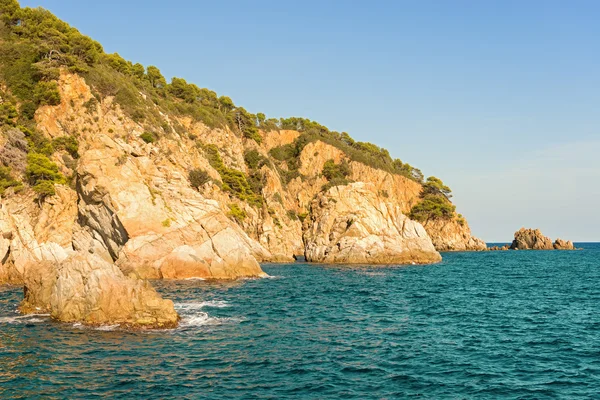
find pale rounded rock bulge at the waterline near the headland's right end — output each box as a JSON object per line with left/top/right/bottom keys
{"left": 304, "top": 183, "right": 441, "bottom": 264}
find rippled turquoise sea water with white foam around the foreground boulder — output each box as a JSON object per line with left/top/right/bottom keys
{"left": 0, "top": 244, "right": 600, "bottom": 399}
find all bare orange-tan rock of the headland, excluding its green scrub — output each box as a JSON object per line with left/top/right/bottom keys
{"left": 0, "top": 71, "right": 480, "bottom": 327}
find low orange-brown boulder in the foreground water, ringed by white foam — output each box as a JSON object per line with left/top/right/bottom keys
{"left": 21, "top": 253, "right": 179, "bottom": 329}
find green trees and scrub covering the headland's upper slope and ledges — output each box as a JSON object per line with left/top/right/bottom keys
{"left": 0, "top": 0, "right": 474, "bottom": 247}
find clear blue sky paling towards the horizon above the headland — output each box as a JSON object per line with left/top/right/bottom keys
{"left": 21, "top": 0, "right": 600, "bottom": 242}
